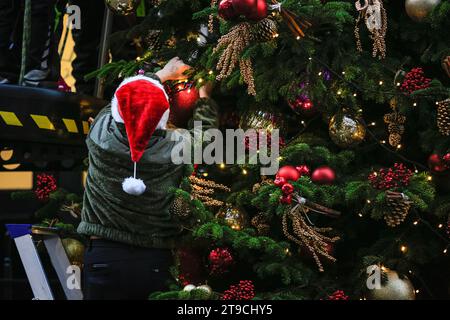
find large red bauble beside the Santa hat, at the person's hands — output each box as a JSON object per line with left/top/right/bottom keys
{"left": 168, "top": 83, "right": 200, "bottom": 128}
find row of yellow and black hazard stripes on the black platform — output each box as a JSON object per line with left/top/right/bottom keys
{"left": 0, "top": 108, "right": 89, "bottom": 135}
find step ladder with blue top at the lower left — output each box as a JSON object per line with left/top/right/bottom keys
{"left": 6, "top": 224, "right": 83, "bottom": 300}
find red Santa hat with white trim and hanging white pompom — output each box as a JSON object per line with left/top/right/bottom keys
{"left": 111, "top": 75, "right": 169, "bottom": 196}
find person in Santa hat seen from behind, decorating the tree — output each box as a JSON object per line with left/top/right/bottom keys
{"left": 78, "top": 58, "right": 218, "bottom": 299}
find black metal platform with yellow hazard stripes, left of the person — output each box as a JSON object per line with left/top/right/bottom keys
{"left": 0, "top": 85, "right": 106, "bottom": 170}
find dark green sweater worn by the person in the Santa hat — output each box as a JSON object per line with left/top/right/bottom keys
{"left": 78, "top": 92, "right": 217, "bottom": 248}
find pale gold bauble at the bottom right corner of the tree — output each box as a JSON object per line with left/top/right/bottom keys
{"left": 367, "top": 268, "right": 416, "bottom": 300}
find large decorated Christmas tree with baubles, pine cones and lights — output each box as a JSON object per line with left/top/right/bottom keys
{"left": 89, "top": 0, "right": 450, "bottom": 300}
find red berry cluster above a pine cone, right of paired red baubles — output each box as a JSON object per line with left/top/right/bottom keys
{"left": 368, "top": 163, "right": 413, "bottom": 190}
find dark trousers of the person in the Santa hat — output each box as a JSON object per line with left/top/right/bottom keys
{"left": 83, "top": 240, "right": 173, "bottom": 300}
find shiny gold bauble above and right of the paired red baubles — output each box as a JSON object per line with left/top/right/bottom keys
{"left": 328, "top": 115, "right": 366, "bottom": 148}
